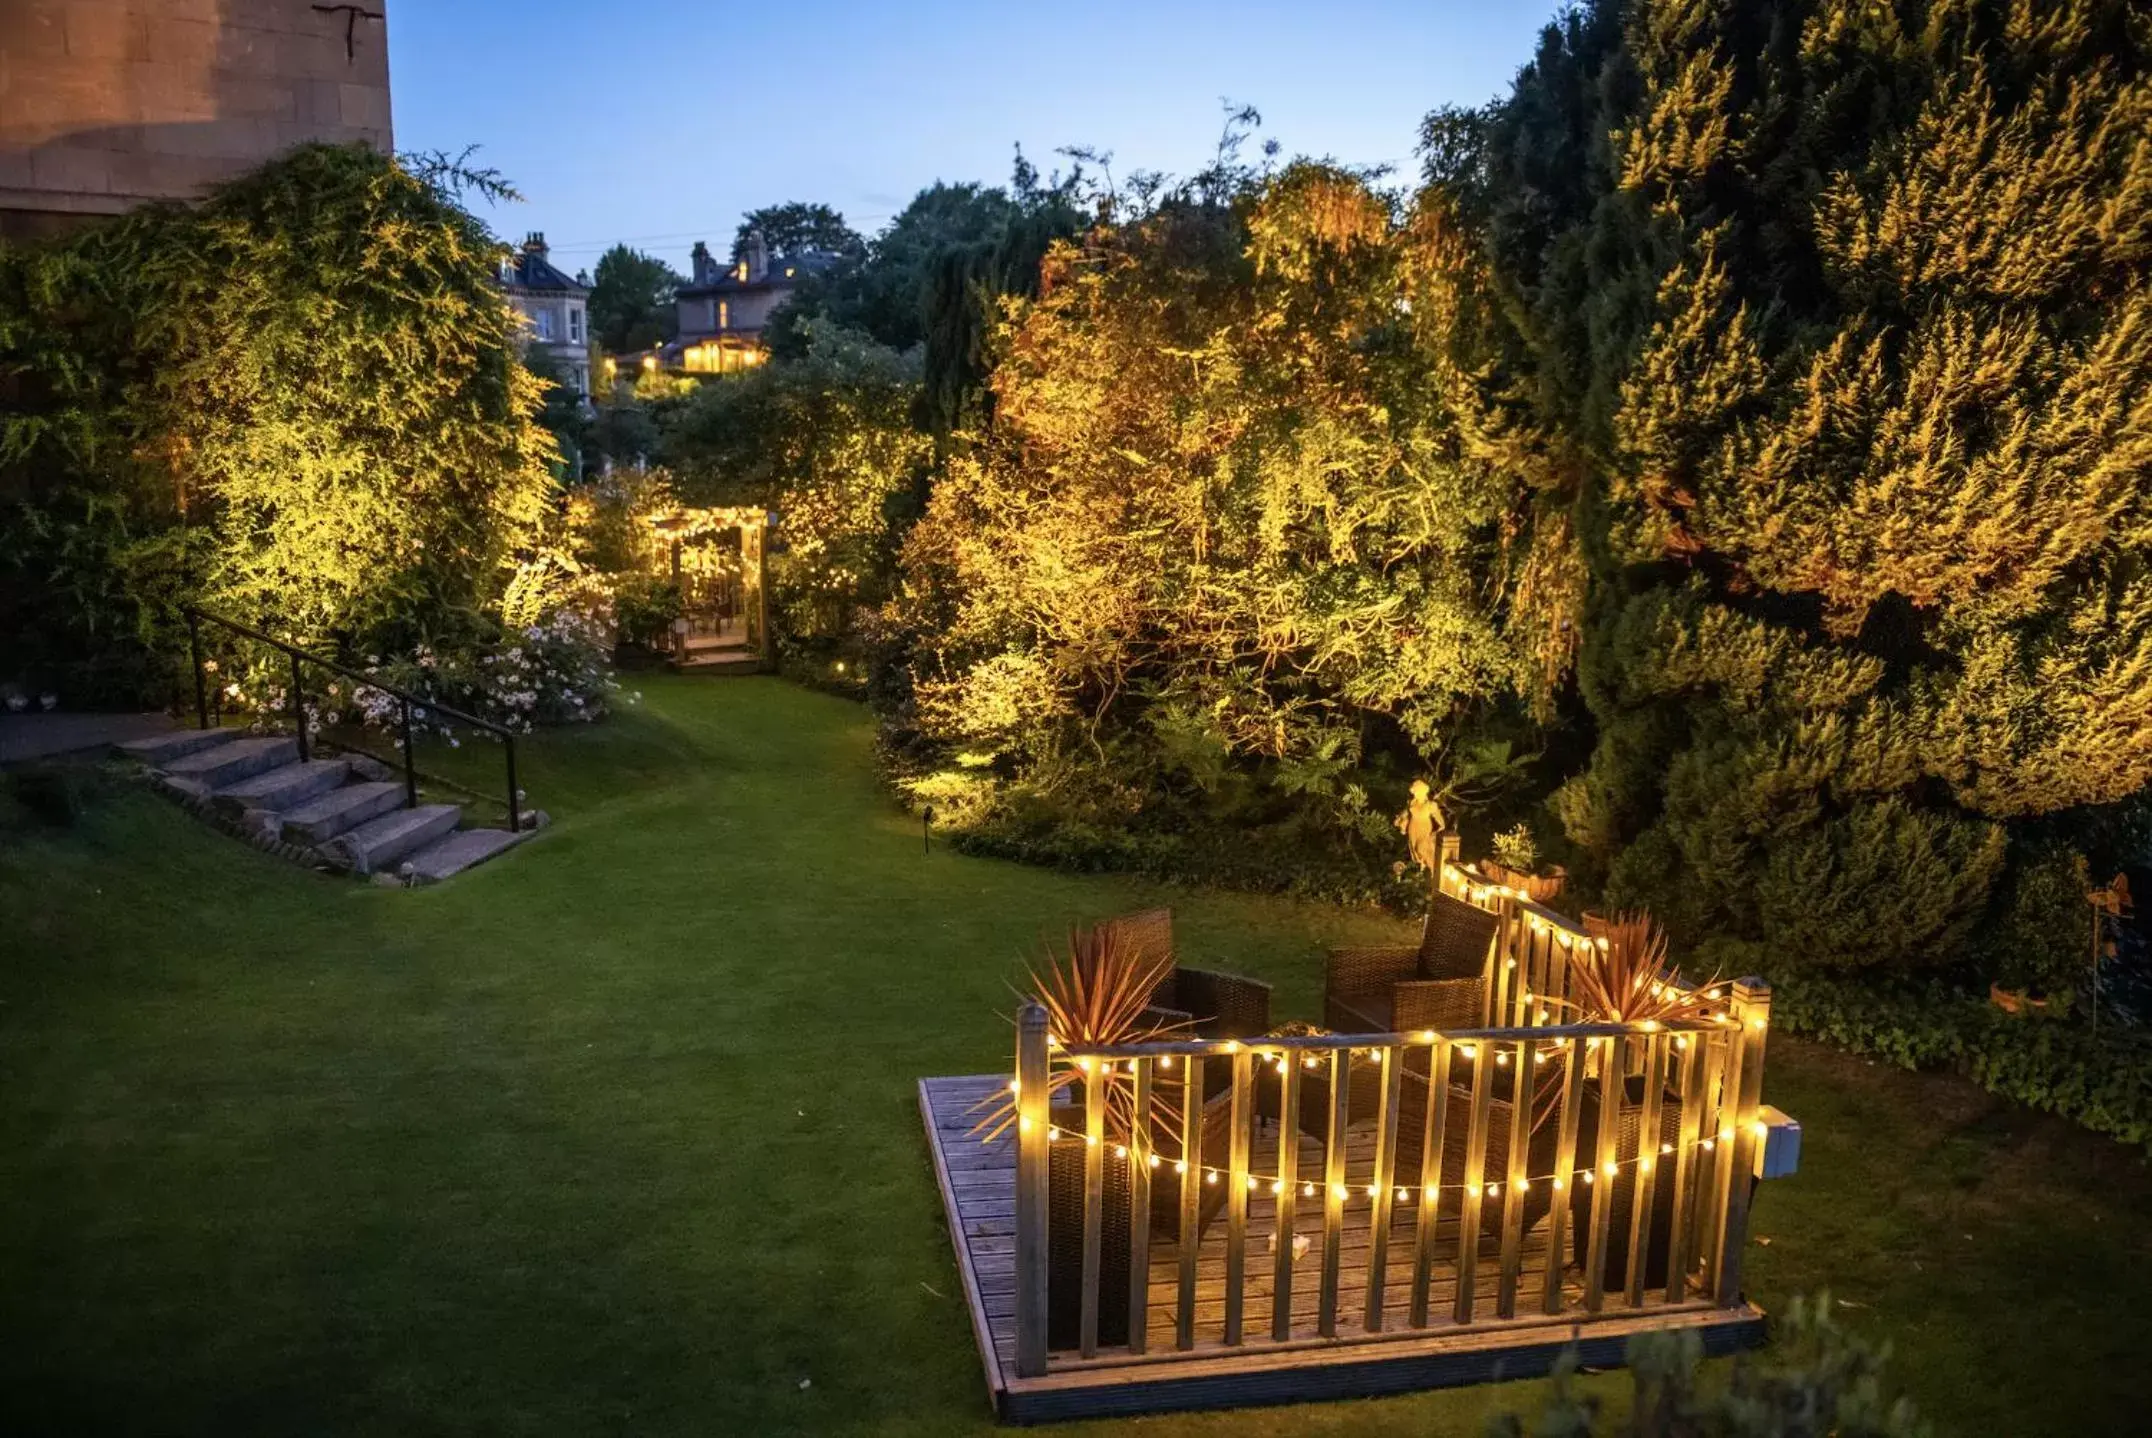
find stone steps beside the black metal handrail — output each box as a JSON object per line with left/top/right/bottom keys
{"left": 116, "top": 730, "right": 532, "bottom": 883}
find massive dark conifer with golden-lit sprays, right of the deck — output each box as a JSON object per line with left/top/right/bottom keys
{"left": 1444, "top": 0, "right": 2152, "bottom": 967}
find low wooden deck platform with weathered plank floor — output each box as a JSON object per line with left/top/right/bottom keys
{"left": 919, "top": 1074, "right": 1762, "bottom": 1423}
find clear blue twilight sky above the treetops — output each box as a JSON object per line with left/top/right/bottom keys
{"left": 385, "top": 0, "right": 1558, "bottom": 271}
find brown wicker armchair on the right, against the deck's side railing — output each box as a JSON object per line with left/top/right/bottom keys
{"left": 1323, "top": 893, "right": 1498, "bottom": 1033}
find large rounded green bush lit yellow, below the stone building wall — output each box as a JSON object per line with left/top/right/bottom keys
{"left": 0, "top": 144, "right": 555, "bottom": 700}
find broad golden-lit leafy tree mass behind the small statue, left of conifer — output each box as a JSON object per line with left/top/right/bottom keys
{"left": 897, "top": 164, "right": 1524, "bottom": 863}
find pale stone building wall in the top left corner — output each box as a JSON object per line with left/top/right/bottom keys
{"left": 0, "top": 0, "right": 392, "bottom": 235}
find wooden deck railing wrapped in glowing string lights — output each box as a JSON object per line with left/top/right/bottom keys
{"left": 1014, "top": 870, "right": 1771, "bottom": 1376}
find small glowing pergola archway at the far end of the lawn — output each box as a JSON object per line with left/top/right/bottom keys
{"left": 650, "top": 504, "right": 777, "bottom": 669}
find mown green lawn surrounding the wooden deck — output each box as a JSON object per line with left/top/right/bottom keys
{"left": 0, "top": 680, "right": 2152, "bottom": 1436}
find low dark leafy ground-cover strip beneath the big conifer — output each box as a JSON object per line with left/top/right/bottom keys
{"left": 1771, "top": 975, "right": 2152, "bottom": 1147}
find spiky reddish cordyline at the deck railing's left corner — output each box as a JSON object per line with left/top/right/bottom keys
{"left": 973, "top": 924, "right": 1188, "bottom": 1143}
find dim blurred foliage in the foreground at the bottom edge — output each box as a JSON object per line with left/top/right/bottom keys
{"left": 1487, "top": 1292, "right": 1928, "bottom": 1438}
